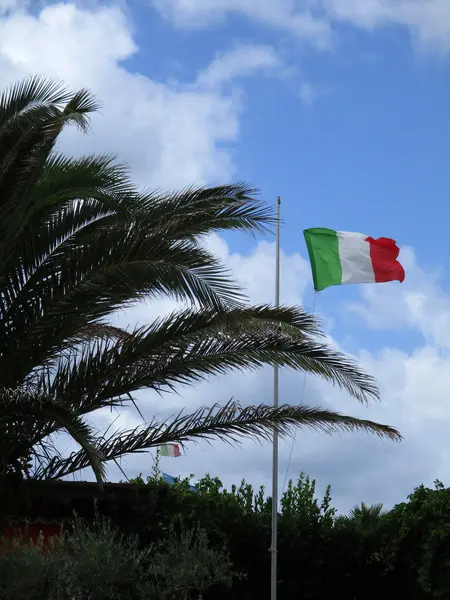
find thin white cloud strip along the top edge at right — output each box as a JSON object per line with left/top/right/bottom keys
{"left": 152, "top": 0, "right": 450, "bottom": 53}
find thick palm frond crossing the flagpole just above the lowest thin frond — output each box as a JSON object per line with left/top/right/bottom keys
{"left": 37, "top": 306, "right": 378, "bottom": 412}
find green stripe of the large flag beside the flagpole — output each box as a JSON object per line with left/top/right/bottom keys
{"left": 303, "top": 227, "right": 342, "bottom": 292}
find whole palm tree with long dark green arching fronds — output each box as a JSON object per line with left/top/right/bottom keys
{"left": 0, "top": 77, "right": 400, "bottom": 488}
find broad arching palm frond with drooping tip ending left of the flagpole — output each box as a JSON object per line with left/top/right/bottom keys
{"left": 0, "top": 221, "right": 250, "bottom": 385}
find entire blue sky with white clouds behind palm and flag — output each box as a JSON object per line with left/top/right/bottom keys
{"left": 0, "top": 0, "right": 450, "bottom": 510}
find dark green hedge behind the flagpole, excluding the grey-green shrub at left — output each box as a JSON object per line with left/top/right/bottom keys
{"left": 120, "top": 473, "right": 450, "bottom": 600}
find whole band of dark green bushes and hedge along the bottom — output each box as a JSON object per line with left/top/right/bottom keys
{"left": 8, "top": 470, "right": 450, "bottom": 600}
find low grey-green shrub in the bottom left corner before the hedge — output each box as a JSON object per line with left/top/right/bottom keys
{"left": 0, "top": 519, "right": 231, "bottom": 600}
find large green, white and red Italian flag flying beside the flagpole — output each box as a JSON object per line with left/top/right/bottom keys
{"left": 304, "top": 227, "right": 405, "bottom": 292}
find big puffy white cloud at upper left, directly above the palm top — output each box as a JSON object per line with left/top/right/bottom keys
{"left": 0, "top": 3, "right": 279, "bottom": 188}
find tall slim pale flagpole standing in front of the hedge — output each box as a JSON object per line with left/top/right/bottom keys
{"left": 270, "top": 196, "right": 281, "bottom": 600}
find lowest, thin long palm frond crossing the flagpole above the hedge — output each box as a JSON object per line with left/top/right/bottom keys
{"left": 35, "top": 402, "right": 401, "bottom": 479}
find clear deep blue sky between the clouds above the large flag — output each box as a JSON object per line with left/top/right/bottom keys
{"left": 125, "top": 0, "right": 450, "bottom": 301}
